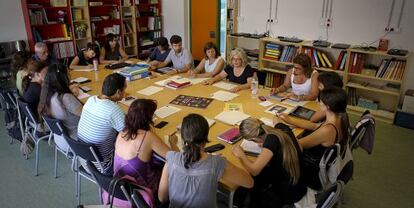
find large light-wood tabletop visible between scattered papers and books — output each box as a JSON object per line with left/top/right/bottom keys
{"left": 70, "top": 61, "right": 319, "bottom": 207}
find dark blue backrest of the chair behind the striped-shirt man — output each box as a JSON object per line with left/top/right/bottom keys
{"left": 63, "top": 135, "right": 102, "bottom": 163}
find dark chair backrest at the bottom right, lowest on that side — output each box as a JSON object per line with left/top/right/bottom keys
{"left": 316, "top": 181, "right": 344, "bottom": 208}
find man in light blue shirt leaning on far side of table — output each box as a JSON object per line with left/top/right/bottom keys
{"left": 151, "top": 35, "right": 194, "bottom": 75}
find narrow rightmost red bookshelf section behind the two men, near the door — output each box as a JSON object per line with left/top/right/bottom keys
{"left": 135, "top": 0, "right": 163, "bottom": 54}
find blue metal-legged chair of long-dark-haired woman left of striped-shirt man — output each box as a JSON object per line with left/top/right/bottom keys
{"left": 42, "top": 116, "right": 73, "bottom": 178}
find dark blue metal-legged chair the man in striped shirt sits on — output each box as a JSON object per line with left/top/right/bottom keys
{"left": 63, "top": 135, "right": 103, "bottom": 205}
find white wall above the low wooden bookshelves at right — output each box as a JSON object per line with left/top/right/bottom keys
{"left": 238, "top": 0, "right": 414, "bottom": 89}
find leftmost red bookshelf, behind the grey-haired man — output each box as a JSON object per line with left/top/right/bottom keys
{"left": 21, "top": 0, "right": 76, "bottom": 59}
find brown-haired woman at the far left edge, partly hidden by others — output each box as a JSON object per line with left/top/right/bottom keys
{"left": 11, "top": 51, "right": 33, "bottom": 95}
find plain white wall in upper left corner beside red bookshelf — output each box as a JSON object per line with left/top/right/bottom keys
{"left": 0, "top": 0, "right": 27, "bottom": 42}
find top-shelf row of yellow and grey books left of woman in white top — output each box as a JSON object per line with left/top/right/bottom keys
{"left": 264, "top": 43, "right": 298, "bottom": 62}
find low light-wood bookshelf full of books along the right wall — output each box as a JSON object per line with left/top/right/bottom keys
{"left": 259, "top": 38, "right": 411, "bottom": 123}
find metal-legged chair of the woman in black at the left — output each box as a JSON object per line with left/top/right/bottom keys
{"left": 16, "top": 98, "right": 49, "bottom": 176}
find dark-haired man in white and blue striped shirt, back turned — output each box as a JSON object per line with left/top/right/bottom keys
{"left": 78, "top": 73, "right": 127, "bottom": 175}
